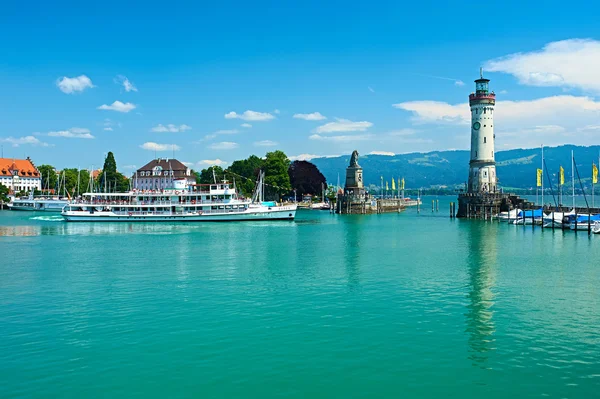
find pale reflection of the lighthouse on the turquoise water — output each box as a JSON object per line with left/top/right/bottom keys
{"left": 466, "top": 222, "right": 498, "bottom": 367}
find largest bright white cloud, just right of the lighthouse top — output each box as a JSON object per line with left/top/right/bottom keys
{"left": 484, "top": 39, "right": 600, "bottom": 93}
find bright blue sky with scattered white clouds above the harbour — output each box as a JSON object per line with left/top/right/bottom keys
{"left": 0, "top": 1, "right": 600, "bottom": 172}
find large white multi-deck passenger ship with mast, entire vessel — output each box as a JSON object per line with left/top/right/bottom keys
{"left": 62, "top": 173, "right": 296, "bottom": 222}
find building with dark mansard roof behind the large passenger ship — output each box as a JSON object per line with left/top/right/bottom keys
{"left": 132, "top": 158, "right": 196, "bottom": 190}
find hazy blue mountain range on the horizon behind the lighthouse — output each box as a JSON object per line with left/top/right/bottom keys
{"left": 311, "top": 145, "right": 600, "bottom": 189}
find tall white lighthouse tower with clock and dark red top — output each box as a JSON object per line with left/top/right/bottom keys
{"left": 467, "top": 72, "right": 497, "bottom": 193}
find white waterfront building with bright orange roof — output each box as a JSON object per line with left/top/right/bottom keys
{"left": 0, "top": 157, "right": 42, "bottom": 193}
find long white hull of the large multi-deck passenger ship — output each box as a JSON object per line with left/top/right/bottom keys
{"left": 62, "top": 206, "right": 296, "bottom": 223}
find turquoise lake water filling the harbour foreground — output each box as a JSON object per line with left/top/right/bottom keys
{"left": 0, "top": 197, "right": 600, "bottom": 398}
